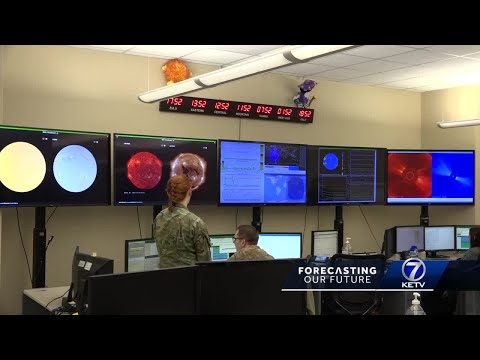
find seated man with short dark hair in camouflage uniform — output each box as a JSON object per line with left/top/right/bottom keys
{"left": 227, "top": 225, "right": 273, "bottom": 261}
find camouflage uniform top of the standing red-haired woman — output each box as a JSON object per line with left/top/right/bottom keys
{"left": 154, "top": 204, "right": 211, "bottom": 268}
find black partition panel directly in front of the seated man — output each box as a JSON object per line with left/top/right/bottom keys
{"left": 197, "top": 259, "right": 306, "bottom": 315}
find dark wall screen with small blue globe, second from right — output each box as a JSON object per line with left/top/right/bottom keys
{"left": 308, "top": 146, "right": 386, "bottom": 205}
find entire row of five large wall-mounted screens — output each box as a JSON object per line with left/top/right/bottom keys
{"left": 0, "top": 126, "right": 475, "bottom": 206}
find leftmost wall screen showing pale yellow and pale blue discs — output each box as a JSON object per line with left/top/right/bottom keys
{"left": 0, "top": 126, "right": 111, "bottom": 207}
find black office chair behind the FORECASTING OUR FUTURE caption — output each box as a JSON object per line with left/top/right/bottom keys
{"left": 322, "top": 254, "right": 386, "bottom": 315}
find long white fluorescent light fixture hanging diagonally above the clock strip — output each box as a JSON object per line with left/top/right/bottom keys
{"left": 138, "top": 45, "right": 361, "bottom": 103}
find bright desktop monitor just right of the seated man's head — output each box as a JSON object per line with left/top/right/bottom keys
{"left": 258, "top": 233, "right": 302, "bottom": 259}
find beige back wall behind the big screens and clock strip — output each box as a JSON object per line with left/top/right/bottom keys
{"left": 0, "top": 46, "right": 422, "bottom": 314}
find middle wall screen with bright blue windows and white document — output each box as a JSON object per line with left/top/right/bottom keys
{"left": 219, "top": 140, "right": 307, "bottom": 206}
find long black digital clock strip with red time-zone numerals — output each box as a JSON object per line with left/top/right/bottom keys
{"left": 160, "top": 96, "right": 314, "bottom": 124}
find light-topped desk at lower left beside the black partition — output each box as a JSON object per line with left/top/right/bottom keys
{"left": 22, "top": 286, "right": 70, "bottom": 315}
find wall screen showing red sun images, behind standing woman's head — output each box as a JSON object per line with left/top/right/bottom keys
{"left": 113, "top": 134, "right": 218, "bottom": 205}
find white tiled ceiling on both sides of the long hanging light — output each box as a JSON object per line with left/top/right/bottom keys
{"left": 70, "top": 45, "right": 480, "bottom": 92}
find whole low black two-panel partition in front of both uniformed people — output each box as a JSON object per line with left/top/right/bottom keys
{"left": 87, "top": 259, "right": 306, "bottom": 315}
